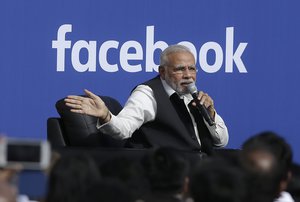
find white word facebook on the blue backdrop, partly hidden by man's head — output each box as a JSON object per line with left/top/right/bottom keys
{"left": 52, "top": 24, "right": 248, "bottom": 73}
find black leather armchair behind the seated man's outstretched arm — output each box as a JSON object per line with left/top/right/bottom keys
{"left": 47, "top": 96, "right": 125, "bottom": 147}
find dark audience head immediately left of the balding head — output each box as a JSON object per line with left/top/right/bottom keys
{"left": 189, "top": 158, "right": 246, "bottom": 202}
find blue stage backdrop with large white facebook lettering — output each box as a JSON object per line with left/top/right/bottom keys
{"left": 0, "top": 0, "right": 300, "bottom": 162}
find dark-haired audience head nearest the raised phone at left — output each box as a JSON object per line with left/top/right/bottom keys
{"left": 46, "top": 154, "right": 100, "bottom": 202}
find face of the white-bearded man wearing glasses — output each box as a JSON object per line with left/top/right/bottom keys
{"left": 159, "top": 52, "right": 196, "bottom": 94}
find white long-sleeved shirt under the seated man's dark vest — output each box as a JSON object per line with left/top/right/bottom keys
{"left": 97, "top": 82, "right": 228, "bottom": 147}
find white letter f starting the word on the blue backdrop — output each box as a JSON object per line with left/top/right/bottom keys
{"left": 52, "top": 24, "right": 72, "bottom": 72}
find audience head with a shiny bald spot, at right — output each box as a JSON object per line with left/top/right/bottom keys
{"left": 241, "top": 132, "right": 292, "bottom": 201}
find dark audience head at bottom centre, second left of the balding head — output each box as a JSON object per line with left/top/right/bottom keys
{"left": 143, "top": 147, "right": 189, "bottom": 202}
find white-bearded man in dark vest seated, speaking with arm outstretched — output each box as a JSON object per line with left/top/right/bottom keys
{"left": 65, "top": 45, "right": 228, "bottom": 153}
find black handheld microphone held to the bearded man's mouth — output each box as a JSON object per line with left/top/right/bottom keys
{"left": 187, "top": 82, "right": 216, "bottom": 126}
